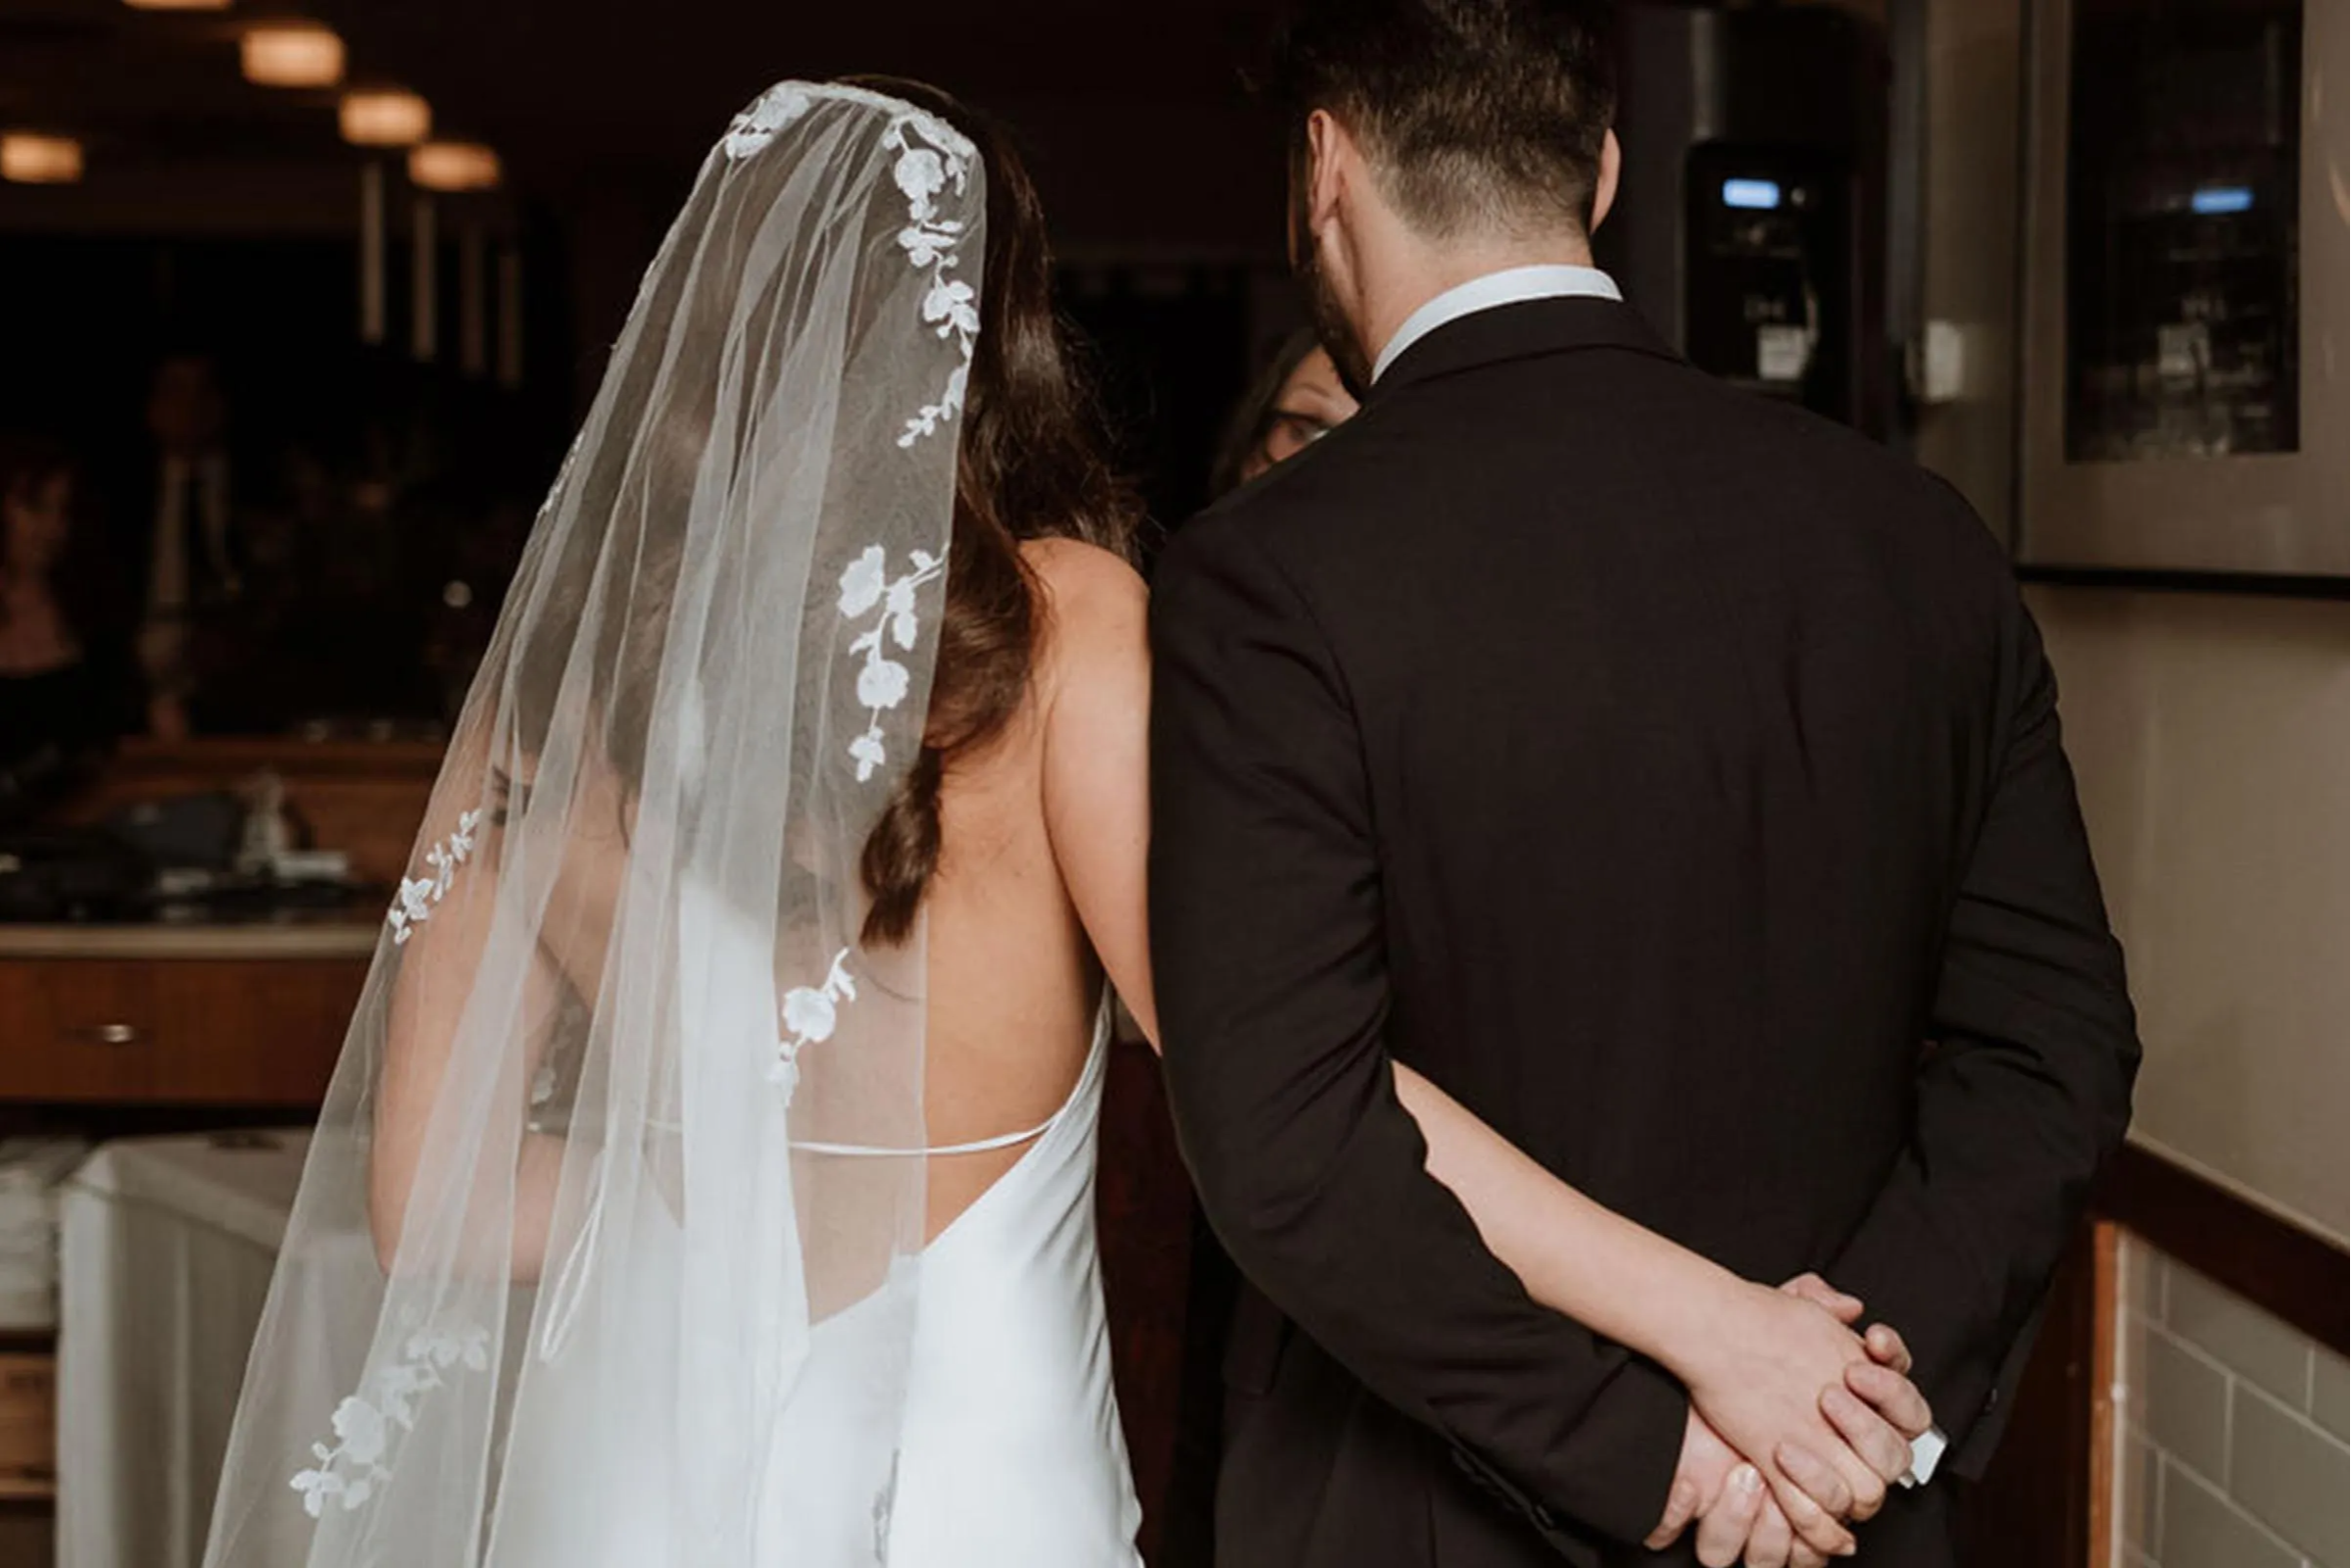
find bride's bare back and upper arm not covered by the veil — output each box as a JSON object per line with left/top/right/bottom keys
{"left": 926, "top": 538, "right": 1150, "bottom": 1237}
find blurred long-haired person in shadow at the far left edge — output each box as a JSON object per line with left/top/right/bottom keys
{"left": 0, "top": 437, "right": 129, "bottom": 823}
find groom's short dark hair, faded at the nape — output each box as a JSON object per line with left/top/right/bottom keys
{"left": 1267, "top": 0, "right": 1615, "bottom": 237}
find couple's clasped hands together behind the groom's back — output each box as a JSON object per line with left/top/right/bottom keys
{"left": 1645, "top": 1274, "right": 1935, "bottom": 1568}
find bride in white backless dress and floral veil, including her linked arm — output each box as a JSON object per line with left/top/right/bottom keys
{"left": 207, "top": 82, "right": 1926, "bottom": 1568}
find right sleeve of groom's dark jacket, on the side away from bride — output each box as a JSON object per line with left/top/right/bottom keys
{"left": 1829, "top": 590, "right": 2139, "bottom": 1474}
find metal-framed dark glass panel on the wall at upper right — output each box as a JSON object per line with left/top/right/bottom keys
{"left": 2017, "top": 0, "right": 2351, "bottom": 595}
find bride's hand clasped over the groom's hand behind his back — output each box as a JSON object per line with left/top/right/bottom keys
{"left": 1667, "top": 1281, "right": 1909, "bottom": 1556}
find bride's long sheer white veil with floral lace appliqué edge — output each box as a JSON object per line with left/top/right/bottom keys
{"left": 207, "top": 82, "right": 985, "bottom": 1568}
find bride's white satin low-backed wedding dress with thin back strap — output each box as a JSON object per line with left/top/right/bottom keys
{"left": 487, "top": 963, "right": 1141, "bottom": 1568}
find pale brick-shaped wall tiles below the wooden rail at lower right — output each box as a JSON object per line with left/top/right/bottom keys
{"left": 2116, "top": 1237, "right": 2351, "bottom": 1568}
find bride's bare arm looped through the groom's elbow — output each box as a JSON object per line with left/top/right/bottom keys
{"left": 1032, "top": 543, "right": 1926, "bottom": 1533}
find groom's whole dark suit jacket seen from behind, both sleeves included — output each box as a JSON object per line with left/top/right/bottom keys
{"left": 1152, "top": 299, "right": 2139, "bottom": 1568}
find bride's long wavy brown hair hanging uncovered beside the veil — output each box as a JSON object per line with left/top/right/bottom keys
{"left": 849, "top": 75, "right": 1141, "bottom": 943}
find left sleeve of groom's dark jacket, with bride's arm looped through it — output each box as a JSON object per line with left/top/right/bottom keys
{"left": 1152, "top": 517, "right": 1688, "bottom": 1551}
